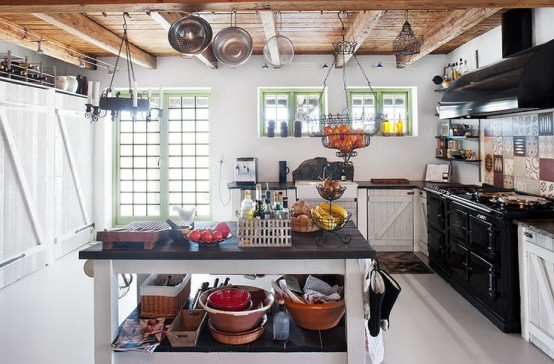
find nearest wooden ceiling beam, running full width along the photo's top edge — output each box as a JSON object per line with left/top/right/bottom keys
{"left": 0, "top": 0, "right": 552, "bottom": 13}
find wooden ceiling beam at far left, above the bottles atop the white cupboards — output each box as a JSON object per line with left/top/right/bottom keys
{"left": 0, "top": 18, "right": 96, "bottom": 70}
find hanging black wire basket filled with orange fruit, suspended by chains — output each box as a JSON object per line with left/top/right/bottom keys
{"left": 305, "top": 11, "right": 383, "bottom": 166}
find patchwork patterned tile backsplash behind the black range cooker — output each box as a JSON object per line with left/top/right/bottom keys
{"left": 482, "top": 111, "right": 554, "bottom": 198}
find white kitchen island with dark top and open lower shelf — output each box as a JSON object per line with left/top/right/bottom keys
{"left": 79, "top": 223, "right": 375, "bottom": 364}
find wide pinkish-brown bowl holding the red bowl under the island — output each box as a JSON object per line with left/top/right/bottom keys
{"left": 198, "top": 285, "right": 274, "bottom": 333}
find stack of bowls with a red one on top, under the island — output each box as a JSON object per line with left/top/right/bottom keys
{"left": 199, "top": 286, "right": 274, "bottom": 345}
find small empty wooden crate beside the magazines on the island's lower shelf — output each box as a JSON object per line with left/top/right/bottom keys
{"left": 167, "top": 310, "right": 207, "bottom": 347}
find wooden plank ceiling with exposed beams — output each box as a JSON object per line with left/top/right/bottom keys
{"left": 0, "top": 0, "right": 552, "bottom": 69}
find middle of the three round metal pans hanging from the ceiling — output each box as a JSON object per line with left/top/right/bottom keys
{"left": 213, "top": 27, "right": 253, "bottom": 66}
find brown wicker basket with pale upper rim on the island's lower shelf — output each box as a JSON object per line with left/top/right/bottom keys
{"left": 140, "top": 274, "right": 190, "bottom": 318}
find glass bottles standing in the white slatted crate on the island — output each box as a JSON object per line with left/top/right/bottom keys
{"left": 240, "top": 183, "right": 290, "bottom": 220}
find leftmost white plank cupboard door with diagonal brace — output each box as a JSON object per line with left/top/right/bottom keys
{"left": 0, "top": 82, "right": 53, "bottom": 288}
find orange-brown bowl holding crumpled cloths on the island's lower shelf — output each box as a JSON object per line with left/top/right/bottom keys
{"left": 285, "top": 300, "right": 345, "bottom": 330}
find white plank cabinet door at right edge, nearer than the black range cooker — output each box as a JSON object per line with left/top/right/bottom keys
{"left": 518, "top": 225, "right": 554, "bottom": 359}
